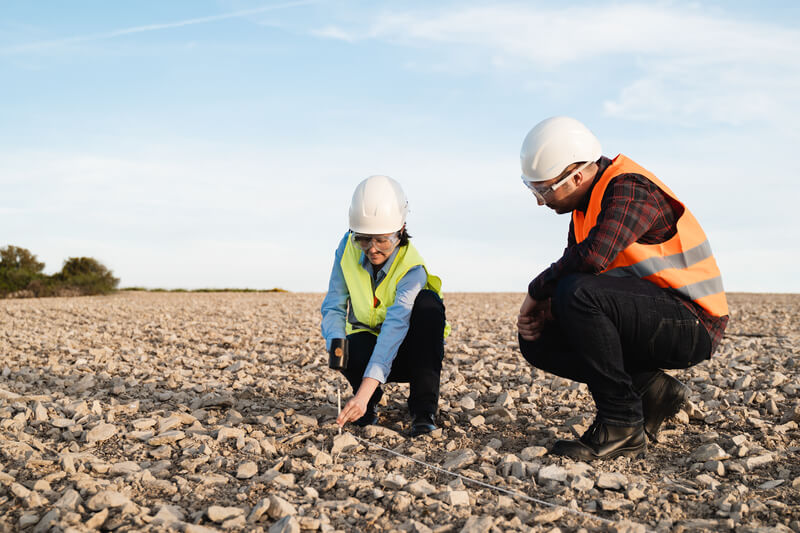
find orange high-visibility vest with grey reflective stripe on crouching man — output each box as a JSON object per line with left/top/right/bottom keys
{"left": 572, "top": 154, "right": 728, "bottom": 316}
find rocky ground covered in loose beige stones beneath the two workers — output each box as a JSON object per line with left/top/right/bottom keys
{"left": 0, "top": 293, "right": 800, "bottom": 532}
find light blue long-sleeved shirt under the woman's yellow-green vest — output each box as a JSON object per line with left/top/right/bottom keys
{"left": 321, "top": 231, "right": 428, "bottom": 383}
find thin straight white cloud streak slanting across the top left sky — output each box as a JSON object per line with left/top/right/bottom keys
{"left": 0, "top": 0, "right": 321, "bottom": 55}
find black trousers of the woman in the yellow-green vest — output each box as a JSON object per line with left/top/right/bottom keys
{"left": 342, "top": 290, "right": 445, "bottom": 414}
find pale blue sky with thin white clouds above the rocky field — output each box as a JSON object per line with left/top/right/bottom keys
{"left": 0, "top": 0, "right": 800, "bottom": 292}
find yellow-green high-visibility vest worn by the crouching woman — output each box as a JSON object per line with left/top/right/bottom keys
{"left": 340, "top": 238, "right": 450, "bottom": 337}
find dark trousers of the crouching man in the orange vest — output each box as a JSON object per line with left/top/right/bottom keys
{"left": 519, "top": 274, "right": 711, "bottom": 426}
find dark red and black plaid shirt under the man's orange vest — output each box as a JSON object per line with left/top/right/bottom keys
{"left": 528, "top": 157, "right": 728, "bottom": 353}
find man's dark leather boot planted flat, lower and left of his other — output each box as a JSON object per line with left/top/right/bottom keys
{"left": 550, "top": 420, "right": 647, "bottom": 461}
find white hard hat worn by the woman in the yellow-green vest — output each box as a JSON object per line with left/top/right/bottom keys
{"left": 350, "top": 176, "right": 408, "bottom": 235}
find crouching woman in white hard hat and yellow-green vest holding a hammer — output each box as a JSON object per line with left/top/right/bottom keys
{"left": 321, "top": 176, "right": 449, "bottom": 436}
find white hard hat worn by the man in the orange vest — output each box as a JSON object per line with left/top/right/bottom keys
{"left": 519, "top": 117, "right": 602, "bottom": 182}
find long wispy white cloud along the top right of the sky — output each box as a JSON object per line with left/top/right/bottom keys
{"left": 314, "top": 4, "right": 800, "bottom": 66}
